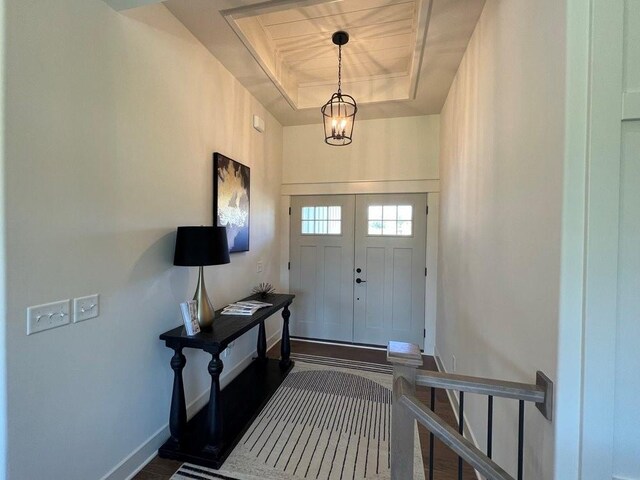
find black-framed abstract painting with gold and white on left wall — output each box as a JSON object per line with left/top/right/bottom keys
{"left": 213, "top": 152, "right": 250, "bottom": 253}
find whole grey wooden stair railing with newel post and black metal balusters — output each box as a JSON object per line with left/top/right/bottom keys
{"left": 387, "top": 342, "right": 553, "bottom": 480}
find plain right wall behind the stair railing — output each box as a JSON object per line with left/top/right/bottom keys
{"left": 436, "top": 0, "right": 566, "bottom": 479}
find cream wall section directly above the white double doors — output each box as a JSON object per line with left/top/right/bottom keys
{"left": 282, "top": 115, "right": 440, "bottom": 185}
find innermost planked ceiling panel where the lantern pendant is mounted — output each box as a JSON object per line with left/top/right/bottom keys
{"left": 258, "top": 0, "right": 418, "bottom": 83}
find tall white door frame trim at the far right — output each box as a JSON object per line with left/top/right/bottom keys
{"left": 554, "top": 0, "right": 624, "bottom": 480}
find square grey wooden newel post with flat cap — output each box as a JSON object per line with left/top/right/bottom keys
{"left": 387, "top": 342, "right": 422, "bottom": 480}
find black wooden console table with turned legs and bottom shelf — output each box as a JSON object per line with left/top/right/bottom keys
{"left": 158, "top": 294, "right": 295, "bottom": 468}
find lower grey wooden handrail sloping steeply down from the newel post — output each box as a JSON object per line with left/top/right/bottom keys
{"left": 394, "top": 377, "right": 514, "bottom": 480}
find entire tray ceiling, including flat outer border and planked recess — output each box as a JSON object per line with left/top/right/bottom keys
{"left": 165, "top": 0, "right": 484, "bottom": 125}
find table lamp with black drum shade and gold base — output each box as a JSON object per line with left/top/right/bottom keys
{"left": 173, "top": 227, "right": 230, "bottom": 329}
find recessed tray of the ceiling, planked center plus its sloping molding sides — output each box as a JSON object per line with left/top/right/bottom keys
{"left": 226, "top": 0, "right": 430, "bottom": 109}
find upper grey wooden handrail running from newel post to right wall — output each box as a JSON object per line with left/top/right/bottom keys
{"left": 416, "top": 371, "right": 547, "bottom": 403}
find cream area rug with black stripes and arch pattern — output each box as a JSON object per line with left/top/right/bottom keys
{"left": 172, "top": 354, "right": 424, "bottom": 480}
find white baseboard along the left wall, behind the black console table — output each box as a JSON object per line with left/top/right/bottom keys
{"left": 101, "top": 330, "right": 282, "bottom": 480}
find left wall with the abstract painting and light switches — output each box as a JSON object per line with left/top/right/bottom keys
{"left": 4, "top": 0, "right": 282, "bottom": 480}
